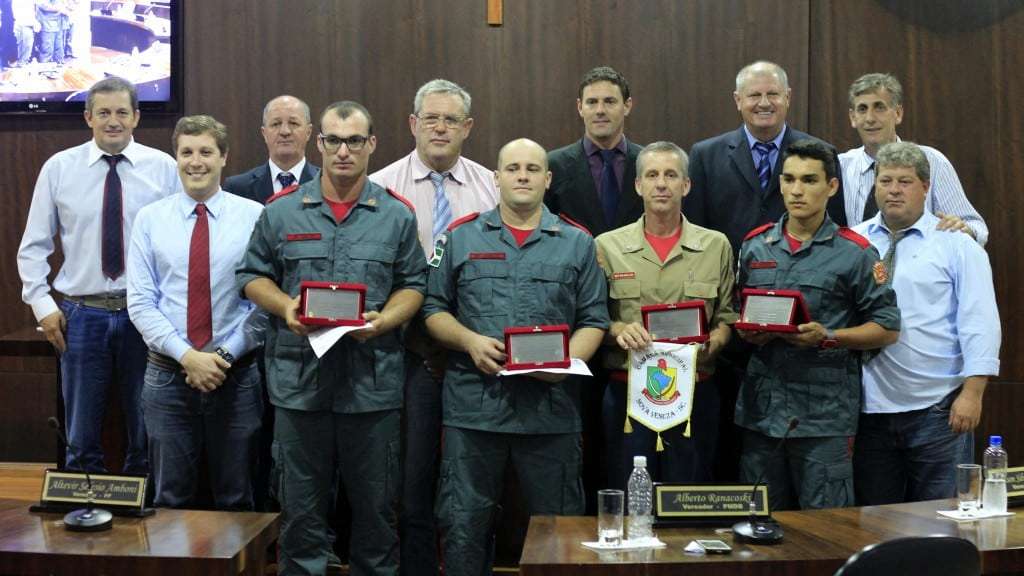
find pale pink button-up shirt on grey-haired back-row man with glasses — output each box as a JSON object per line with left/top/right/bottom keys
{"left": 370, "top": 150, "right": 499, "bottom": 259}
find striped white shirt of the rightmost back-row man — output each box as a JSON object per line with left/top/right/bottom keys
{"left": 839, "top": 145, "right": 988, "bottom": 246}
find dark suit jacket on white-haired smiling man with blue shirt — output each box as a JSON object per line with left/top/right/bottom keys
{"left": 683, "top": 126, "right": 846, "bottom": 253}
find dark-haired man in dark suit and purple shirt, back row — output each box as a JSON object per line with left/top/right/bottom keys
{"left": 544, "top": 66, "right": 643, "bottom": 236}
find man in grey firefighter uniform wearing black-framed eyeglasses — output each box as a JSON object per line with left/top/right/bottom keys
{"left": 237, "top": 101, "right": 426, "bottom": 575}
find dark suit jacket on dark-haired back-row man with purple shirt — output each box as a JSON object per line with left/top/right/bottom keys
{"left": 544, "top": 139, "right": 643, "bottom": 237}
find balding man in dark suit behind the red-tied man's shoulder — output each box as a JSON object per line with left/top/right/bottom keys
{"left": 223, "top": 95, "right": 319, "bottom": 204}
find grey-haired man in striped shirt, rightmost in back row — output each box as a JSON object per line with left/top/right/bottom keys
{"left": 839, "top": 73, "right": 988, "bottom": 246}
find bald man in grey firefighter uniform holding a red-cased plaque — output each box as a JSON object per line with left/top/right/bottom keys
{"left": 424, "top": 139, "right": 608, "bottom": 576}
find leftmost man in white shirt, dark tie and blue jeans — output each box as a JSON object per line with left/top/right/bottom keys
{"left": 17, "top": 77, "right": 181, "bottom": 474}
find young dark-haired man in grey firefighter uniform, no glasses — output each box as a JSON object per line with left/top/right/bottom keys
{"left": 736, "top": 139, "right": 900, "bottom": 509}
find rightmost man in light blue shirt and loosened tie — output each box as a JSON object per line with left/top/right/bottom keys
{"left": 854, "top": 142, "right": 1000, "bottom": 505}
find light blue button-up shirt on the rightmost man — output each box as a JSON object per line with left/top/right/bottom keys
{"left": 856, "top": 211, "right": 1001, "bottom": 413}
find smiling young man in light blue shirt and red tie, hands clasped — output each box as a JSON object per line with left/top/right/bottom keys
{"left": 127, "top": 116, "right": 263, "bottom": 509}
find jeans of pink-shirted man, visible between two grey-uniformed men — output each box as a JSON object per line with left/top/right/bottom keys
{"left": 398, "top": 352, "right": 441, "bottom": 576}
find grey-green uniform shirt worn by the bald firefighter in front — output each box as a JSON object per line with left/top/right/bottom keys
{"left": 423, "top": 207, "right": 608, "bottom": 434}
